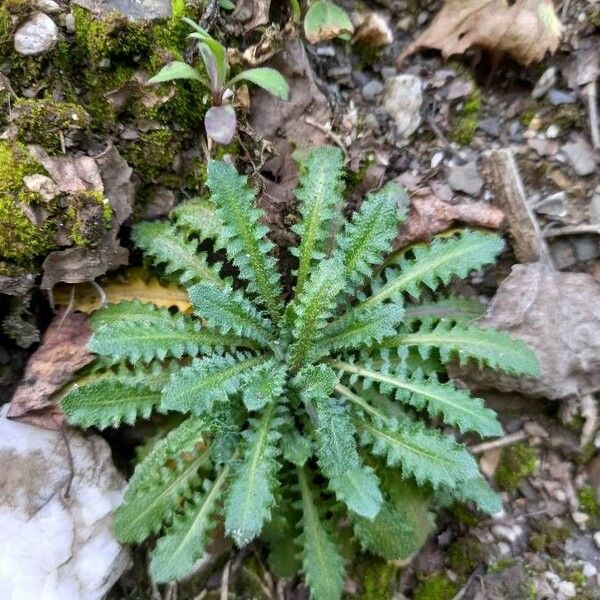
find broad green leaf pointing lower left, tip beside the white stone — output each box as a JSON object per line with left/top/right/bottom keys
{"left": 114, "top": 417, "right": 215, "bottom": 542}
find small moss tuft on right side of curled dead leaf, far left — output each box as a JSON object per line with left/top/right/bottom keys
{"left": 64, "top": 190, "right": 112, "bottom": 246}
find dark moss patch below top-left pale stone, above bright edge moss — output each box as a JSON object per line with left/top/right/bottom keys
{"left": 14, "top": 98, "right": 91, "bottom": 152}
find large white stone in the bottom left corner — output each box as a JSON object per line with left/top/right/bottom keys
{"left": 0, "top": 415, "right": 129, "bottom": 600}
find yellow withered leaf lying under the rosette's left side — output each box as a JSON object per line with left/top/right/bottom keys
{"left": 54, "top": 268, "right": 191, "bottom": 315}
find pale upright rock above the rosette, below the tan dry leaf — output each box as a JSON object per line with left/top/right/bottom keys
{"left": 383, "top": 75, "right": 423, "bottom": 139}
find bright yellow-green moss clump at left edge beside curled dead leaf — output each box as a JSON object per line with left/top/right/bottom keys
{"left": 0, "top": 141, "right": 54, "bottom": 269}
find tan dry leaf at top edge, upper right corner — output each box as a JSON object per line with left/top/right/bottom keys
{"left": 398, "top": 0, "right": 562, "bottom": 65}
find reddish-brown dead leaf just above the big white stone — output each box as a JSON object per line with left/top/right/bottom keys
{"left": 7, "top": 311, "right": 94, "bottom": 429}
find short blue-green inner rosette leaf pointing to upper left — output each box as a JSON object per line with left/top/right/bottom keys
{"left": 188, "top": 283, "right": 273, "bottom": 346}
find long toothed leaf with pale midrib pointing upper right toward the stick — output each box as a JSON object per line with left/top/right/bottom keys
{"left": 362, "top": 229, "right": 504, "bottom": 306}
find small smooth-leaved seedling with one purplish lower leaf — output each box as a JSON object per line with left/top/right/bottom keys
{"left": 148, "top": 18, "right": 290, "bottom": 144}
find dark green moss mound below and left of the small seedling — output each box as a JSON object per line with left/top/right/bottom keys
{"left": 123, "top": 129, "right": 178, "bottom": 186}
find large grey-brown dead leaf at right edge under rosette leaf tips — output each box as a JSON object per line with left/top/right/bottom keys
{"left": 452, "top": 263, "right": 600, "bottom": 400}
